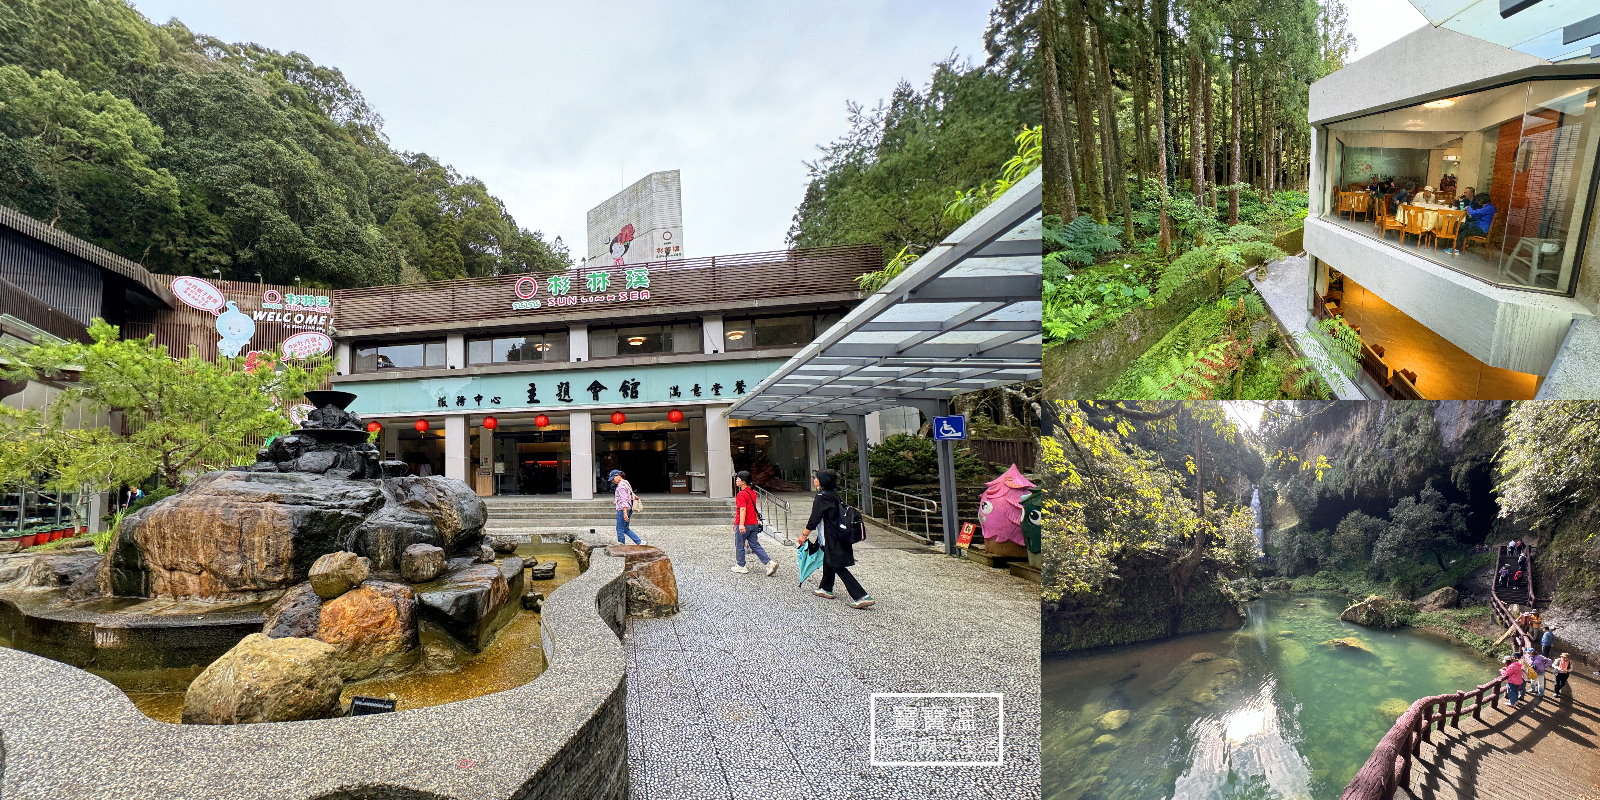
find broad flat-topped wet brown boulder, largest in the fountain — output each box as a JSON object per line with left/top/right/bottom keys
{"left": 101, "top": 470, "right": 384, "bottom": 598}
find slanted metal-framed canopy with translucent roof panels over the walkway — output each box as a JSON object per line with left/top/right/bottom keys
{"left": 728, "top": 170, "right": 1043, "bottom": 555}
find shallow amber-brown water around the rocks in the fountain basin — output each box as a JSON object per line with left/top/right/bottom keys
{"left": 108, "top": 544, "right": 578, "bottom": 722}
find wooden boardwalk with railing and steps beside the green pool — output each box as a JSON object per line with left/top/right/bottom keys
{"left": 1341, "top": 547, "right": 1600, "bottom": 800}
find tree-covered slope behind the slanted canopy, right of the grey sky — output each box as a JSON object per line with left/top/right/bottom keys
{"left": 789, "top": 0, "right": 1040, "bottom": 256}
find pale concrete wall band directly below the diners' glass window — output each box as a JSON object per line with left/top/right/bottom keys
{"left": 1306, "top": 219, "right": 1589, "bottom": 374}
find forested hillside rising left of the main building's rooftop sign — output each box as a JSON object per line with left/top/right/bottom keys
{"left": 0, "top": 0, "right": 566, "bottom": 286}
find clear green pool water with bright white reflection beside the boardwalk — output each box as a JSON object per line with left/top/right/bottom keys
{"left": 1043, "top": 595, "right": 1494, "bottom": 800}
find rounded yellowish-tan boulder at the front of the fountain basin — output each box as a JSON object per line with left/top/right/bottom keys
{"left": 184, "top": 634, "right": 344, "bottom": 725}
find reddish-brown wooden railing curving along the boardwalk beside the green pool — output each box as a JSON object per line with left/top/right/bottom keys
{"left": 1339, "top": 547, "right": 1534, "bottom": 800}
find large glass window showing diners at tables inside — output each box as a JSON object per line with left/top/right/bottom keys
{"left": 1323, "top": 77, "right": 1600, "bottom": 294}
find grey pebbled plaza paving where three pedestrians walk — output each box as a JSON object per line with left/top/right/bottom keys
{"left": 627, "top": 526, "right": 1040, "bottom": 800}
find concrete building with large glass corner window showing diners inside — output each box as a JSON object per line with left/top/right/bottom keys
{"left": 1301, "top": 20, "right": 1600, "bottom": 400}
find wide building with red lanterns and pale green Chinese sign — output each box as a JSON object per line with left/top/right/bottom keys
{"left": 331, "top": 246, "right": 902, "bottom": 499}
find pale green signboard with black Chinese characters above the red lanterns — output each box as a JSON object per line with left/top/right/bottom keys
{"left": 338, "top": 358, "right": 784, "bottom": 416}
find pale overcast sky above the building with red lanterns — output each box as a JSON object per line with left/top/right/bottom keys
{"left": 134, "top": 0, "right": 992, "bottom": 258}
